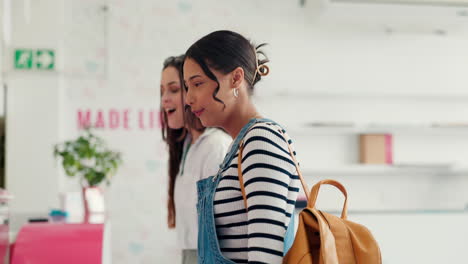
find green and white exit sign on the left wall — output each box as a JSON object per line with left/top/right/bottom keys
{"left": 15, "top": 49, "right": 55, "bottom": 70}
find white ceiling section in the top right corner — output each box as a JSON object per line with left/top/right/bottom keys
{"left": 305, "top": 0, "right": 468, "bottom": 35}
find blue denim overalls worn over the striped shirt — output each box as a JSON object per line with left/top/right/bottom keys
{"left": 197, "top": 118, "right": 294, "bottom": 264}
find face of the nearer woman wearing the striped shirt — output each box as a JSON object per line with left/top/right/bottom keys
{"left": 184, "top": 58, "right": 235, "bottom": 127}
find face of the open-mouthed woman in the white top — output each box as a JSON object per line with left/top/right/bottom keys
{"left": 161, "top": 66, "right": 184, "bottom": 129}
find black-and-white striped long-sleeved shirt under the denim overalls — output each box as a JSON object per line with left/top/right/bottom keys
{"left": 214, "top": 123, "right": 300, "bottom": 264}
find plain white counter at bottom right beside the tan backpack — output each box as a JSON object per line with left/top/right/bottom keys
{"left": 349, "top": 212, "right": 468, "bottom": 264}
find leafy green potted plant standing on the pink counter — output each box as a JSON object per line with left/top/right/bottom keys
{"left": 54, "top": 128, "right": 122, "bottom": 219}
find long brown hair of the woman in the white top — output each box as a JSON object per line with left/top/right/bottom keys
{"left": 160, "top": 55, "right": 205, "bottom": 227}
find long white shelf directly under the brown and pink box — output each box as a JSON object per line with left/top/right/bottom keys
{"left": 302, "top": 164, "right": 468, "bottom": 177}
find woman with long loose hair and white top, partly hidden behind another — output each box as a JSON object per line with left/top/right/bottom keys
{"left": 160, "top": 56, "right": 232, "bottom": 263}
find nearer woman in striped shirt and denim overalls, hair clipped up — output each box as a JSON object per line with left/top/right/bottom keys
{"left": 183, "top": 31, "right": 300, "bottom": 264}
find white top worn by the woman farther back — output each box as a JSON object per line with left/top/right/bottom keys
{"left": 174, "top": 128, "right": 232, "bottom": 249}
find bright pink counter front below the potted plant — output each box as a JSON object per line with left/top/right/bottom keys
{"left": 11, "top": 223, "right": 104, "bottom": 264}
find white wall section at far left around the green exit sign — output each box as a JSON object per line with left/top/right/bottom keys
{"left": 3, "top": 0, "right": 63, "bottom": 212}
